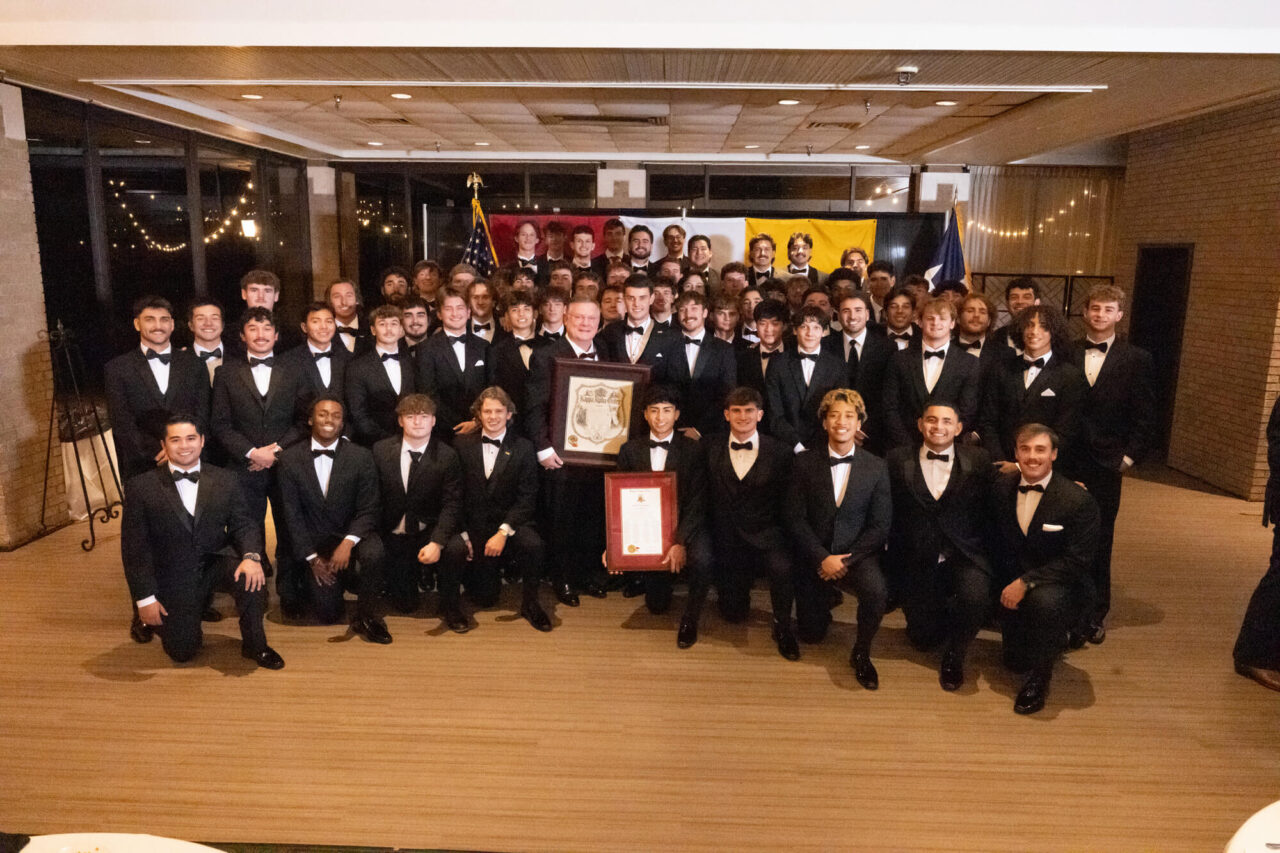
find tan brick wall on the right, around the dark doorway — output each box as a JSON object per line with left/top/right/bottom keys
{"left": 1116, "top": 99, "right": 1280, "bottom": 500}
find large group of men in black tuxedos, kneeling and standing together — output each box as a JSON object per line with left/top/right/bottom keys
{"left": 106, "top": 258, "right": 1153, "bottom": 712}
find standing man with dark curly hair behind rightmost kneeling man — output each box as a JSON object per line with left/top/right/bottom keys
{"left": 978, "top": 305, "right": 1089, "bottom": 474}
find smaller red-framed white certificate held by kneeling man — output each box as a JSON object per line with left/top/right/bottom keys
{"left": 604, "top": 471, "right": 676, "bottom": 571}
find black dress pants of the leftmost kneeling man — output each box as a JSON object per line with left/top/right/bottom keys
{"left": 156, "top": 557, "right": 266, "bottom": 663}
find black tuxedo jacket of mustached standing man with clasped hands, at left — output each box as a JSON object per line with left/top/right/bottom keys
{"left": 211, "top": 355, "right": 312, "bottom": 467}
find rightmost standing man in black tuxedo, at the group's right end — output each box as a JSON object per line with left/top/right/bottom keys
{"left": 1070, "top": 284, "right": 1156, "bottom": 643}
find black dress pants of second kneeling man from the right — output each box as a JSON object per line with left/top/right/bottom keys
{"left": 902, "top": 558, "right": 993, "bottom": 653}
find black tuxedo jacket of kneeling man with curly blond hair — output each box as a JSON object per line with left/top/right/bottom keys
{"left": 786, "top": 442, "right": 893, "bottom": 571}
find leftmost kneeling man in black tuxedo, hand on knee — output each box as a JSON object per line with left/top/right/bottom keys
{"left": 120, "top": 415, "right": 284, "bottom": 670}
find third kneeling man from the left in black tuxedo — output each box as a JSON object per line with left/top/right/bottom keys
{"left": 374, "top": 394, "right": 471, "bottom": 634}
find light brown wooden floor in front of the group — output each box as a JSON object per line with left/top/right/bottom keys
{"left": 0, "top": 473, "right": 1280, "bottom": 852}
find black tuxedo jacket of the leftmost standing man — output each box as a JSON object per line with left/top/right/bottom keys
{"left": 105, "top": 345, "right": 210, "bottom": 482}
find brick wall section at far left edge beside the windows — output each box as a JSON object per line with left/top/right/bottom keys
{"left": 0, "top": 85, "right": 67, "bottom": 549}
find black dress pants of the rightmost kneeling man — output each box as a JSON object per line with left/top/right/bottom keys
{"left": 1001, "top": 584, "right": 1091, "bottom": 674}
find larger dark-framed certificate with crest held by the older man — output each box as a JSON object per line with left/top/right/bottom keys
{"left": 552, "top": 359, "right": 649, "bottom": 467}
